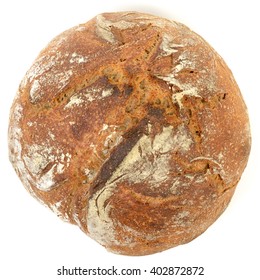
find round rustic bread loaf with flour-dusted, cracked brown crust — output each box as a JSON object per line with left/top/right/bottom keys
{"left": 9, "top": 12, "right": 251, "bottom": 255}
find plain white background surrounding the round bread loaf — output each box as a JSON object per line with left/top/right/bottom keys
{"left": 0, "top": 0, "right": 260, "bottom": 280}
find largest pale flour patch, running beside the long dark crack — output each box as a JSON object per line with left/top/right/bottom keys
{"left": 88, "top": 124, "right": 193, "bottom": 245}
